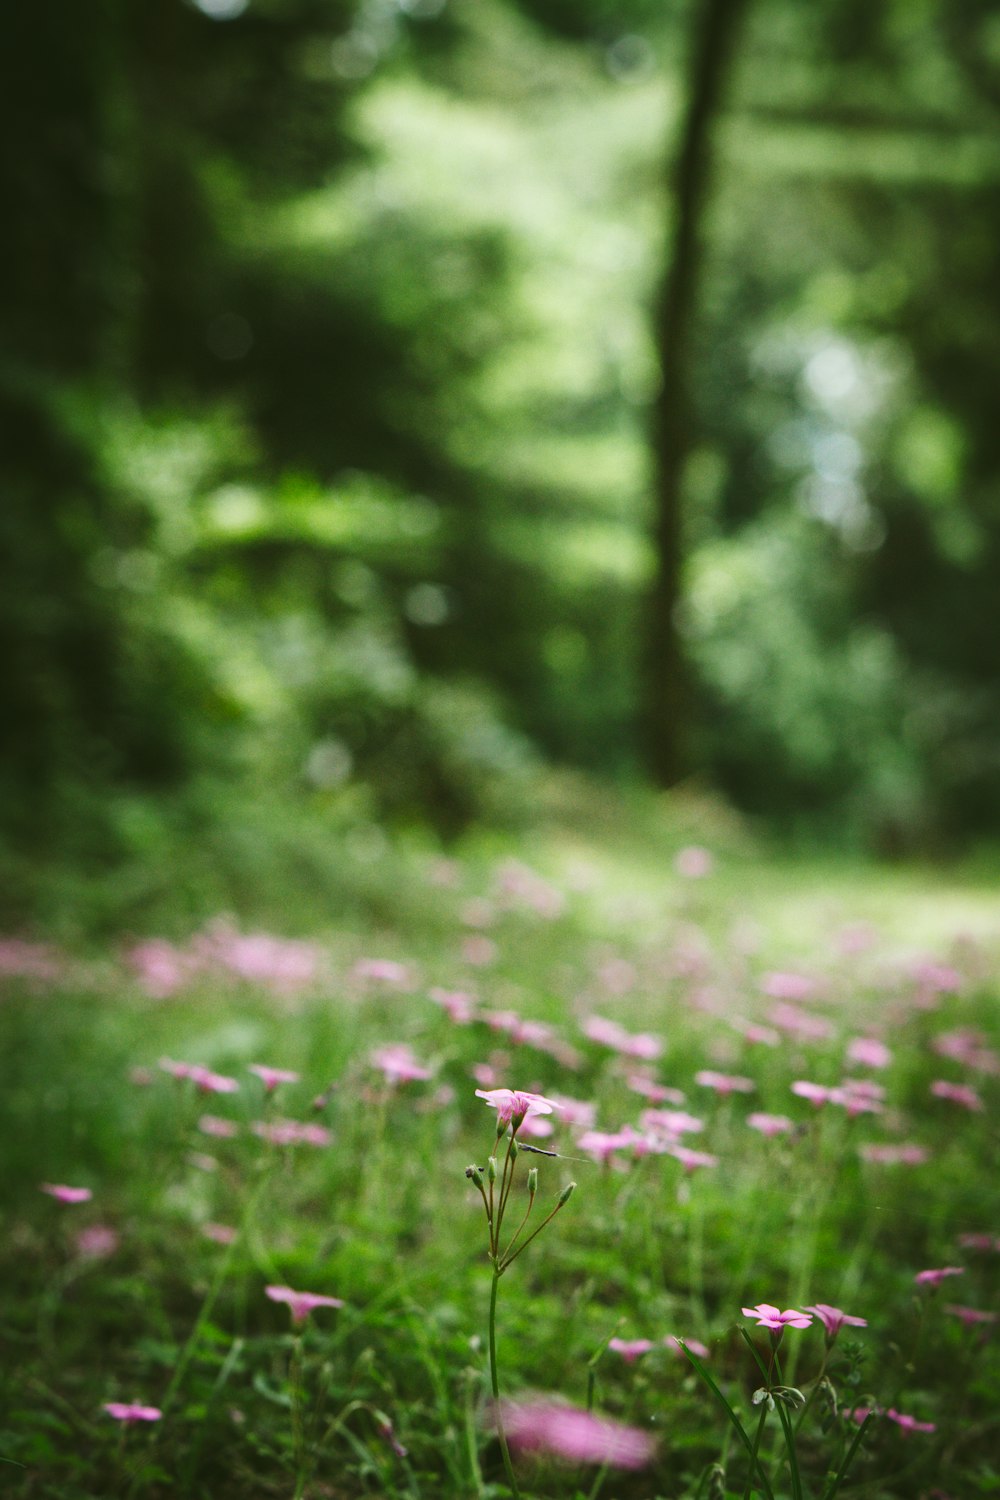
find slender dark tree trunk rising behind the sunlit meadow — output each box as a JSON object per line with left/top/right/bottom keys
{"left": 642, "top": 0, "right": 748, "bottom": 786}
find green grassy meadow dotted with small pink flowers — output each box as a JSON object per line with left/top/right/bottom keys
{"left": 0, "top": 792, "right": 1000, "bottom": 1500}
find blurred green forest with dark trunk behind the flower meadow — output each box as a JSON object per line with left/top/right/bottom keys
{"left": 0, "top": 0, "right": 1000, "bottom": 921}
